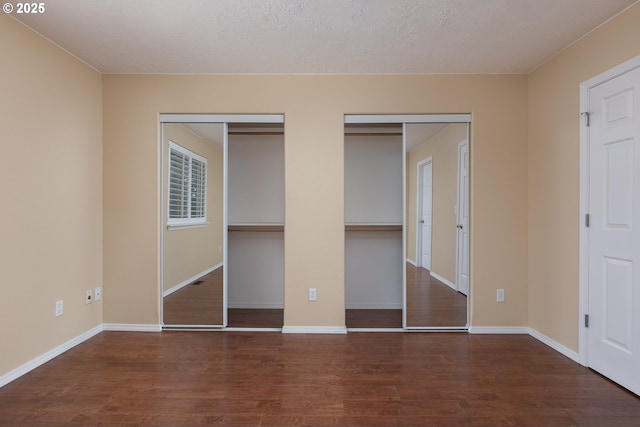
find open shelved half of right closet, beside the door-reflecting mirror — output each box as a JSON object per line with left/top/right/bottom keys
{"left": 344, "top": 123, "right": 404, "bottom": 328}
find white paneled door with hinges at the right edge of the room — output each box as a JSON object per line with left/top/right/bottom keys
{"left": 587, "top": 63, "right": 640, "bottom": 394}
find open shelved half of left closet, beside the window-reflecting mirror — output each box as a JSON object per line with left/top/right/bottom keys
{"left": 227, "top": 123, "right": 284, "bottom": 328}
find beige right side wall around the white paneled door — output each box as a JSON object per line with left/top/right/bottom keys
{"left": 528, "top": 5, "right": 640, "bottom": 351}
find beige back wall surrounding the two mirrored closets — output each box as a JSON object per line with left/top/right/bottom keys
{"left": 103, "top": 75, "right": 527, "bottom": 326}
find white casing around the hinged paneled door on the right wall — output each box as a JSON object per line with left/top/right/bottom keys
{"left": 578, "top": 56, "right": 640, "bottom": 366}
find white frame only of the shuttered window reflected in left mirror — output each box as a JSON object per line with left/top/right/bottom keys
{"left": 167, "top": 140, "right": 208, "bottom": 229}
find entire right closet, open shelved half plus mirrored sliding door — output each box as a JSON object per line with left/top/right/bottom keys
{"left": 345, "top": 115, "right": 470, "bottom": 329}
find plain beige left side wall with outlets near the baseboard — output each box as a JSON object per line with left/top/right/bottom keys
{"left": 0, "top": 13, "right": 102, "bottom": 375}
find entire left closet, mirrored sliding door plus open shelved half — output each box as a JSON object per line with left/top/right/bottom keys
{"left": 161, "top": 114, "right": 284, "bottom": 329}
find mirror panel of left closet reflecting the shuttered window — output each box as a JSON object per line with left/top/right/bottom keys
{"left": 162, "top": 123, "right": 224, "bottom": 327}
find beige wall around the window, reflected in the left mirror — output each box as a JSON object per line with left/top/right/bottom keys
{"left": 162, "top": 123, "right": 224, "bottom": 291}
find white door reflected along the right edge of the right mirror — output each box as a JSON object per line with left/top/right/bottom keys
{"left": 456, "top": 141, "right": 469, "bottom": 295}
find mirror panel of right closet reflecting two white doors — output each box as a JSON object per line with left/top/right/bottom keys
{"left": 405, "top": 123, "right": 469, "bottom": 327}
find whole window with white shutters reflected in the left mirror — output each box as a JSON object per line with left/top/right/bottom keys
{"left": 167, "top": 141, "right": 207, "bottom": 225}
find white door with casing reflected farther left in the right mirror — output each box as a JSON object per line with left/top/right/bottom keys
{"left": 417, "top": 157, "right": 433, "bottom": 270}
